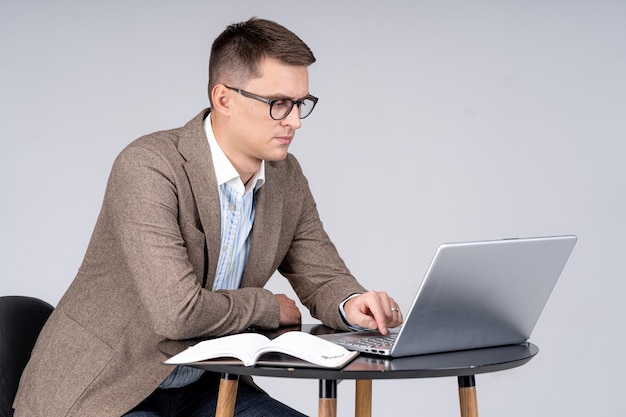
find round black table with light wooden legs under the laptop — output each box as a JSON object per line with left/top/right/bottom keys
{"left": 159, "top": 325, "right": 539, "bottom": 417}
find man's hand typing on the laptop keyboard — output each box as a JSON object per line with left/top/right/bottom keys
{"left": 342, "top": 291, "right": 403, "bottom": 335}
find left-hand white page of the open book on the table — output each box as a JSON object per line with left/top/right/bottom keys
{"left": 165, "top": 333, "right": 270, "bottom": 366}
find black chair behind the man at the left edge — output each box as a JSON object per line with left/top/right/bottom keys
{"left": 0, "top": 296, "right": 53, "bottom": 417}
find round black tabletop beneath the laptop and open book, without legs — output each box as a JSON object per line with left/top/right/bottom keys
{"left": 158, "top": 325, "right": 539, "bottom": 380}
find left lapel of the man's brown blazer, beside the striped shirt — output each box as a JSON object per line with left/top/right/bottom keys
{"left": 179, "top": 110, "right": 222, "bottom": 289}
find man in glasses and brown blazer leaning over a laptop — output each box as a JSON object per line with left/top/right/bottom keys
{"left": 14, "top": 19, "right": 402, "bottom": 417}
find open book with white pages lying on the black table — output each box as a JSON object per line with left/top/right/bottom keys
{"left": 165, "top": 331, "right": 358, "bottom": 368}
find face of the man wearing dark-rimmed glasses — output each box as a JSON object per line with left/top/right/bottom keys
{"left": 227, "top": 59, "right": 309, "bottom": 165}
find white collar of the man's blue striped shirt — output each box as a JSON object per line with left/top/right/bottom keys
{"left": 204, "top": 114, "right": 265, "bottom": 194}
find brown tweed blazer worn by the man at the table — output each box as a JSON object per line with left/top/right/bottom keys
{"left": 14, "top": 110, "right": 365, "bottom": 417}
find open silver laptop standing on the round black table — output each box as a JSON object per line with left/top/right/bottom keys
{"left": 320, "top": 235, "right": 577, "bottom": 357}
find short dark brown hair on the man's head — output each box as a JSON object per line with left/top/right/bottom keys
{"left": 209, "top": 17, "right": 315, "bottom": 104}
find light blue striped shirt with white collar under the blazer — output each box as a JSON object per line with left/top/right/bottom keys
{"left": 159, "top": 113, "right": 265, "bottom": 388}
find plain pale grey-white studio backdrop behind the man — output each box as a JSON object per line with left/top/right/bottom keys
{"left": 0, "top": 0, "right": 626, "bottom": 417}
